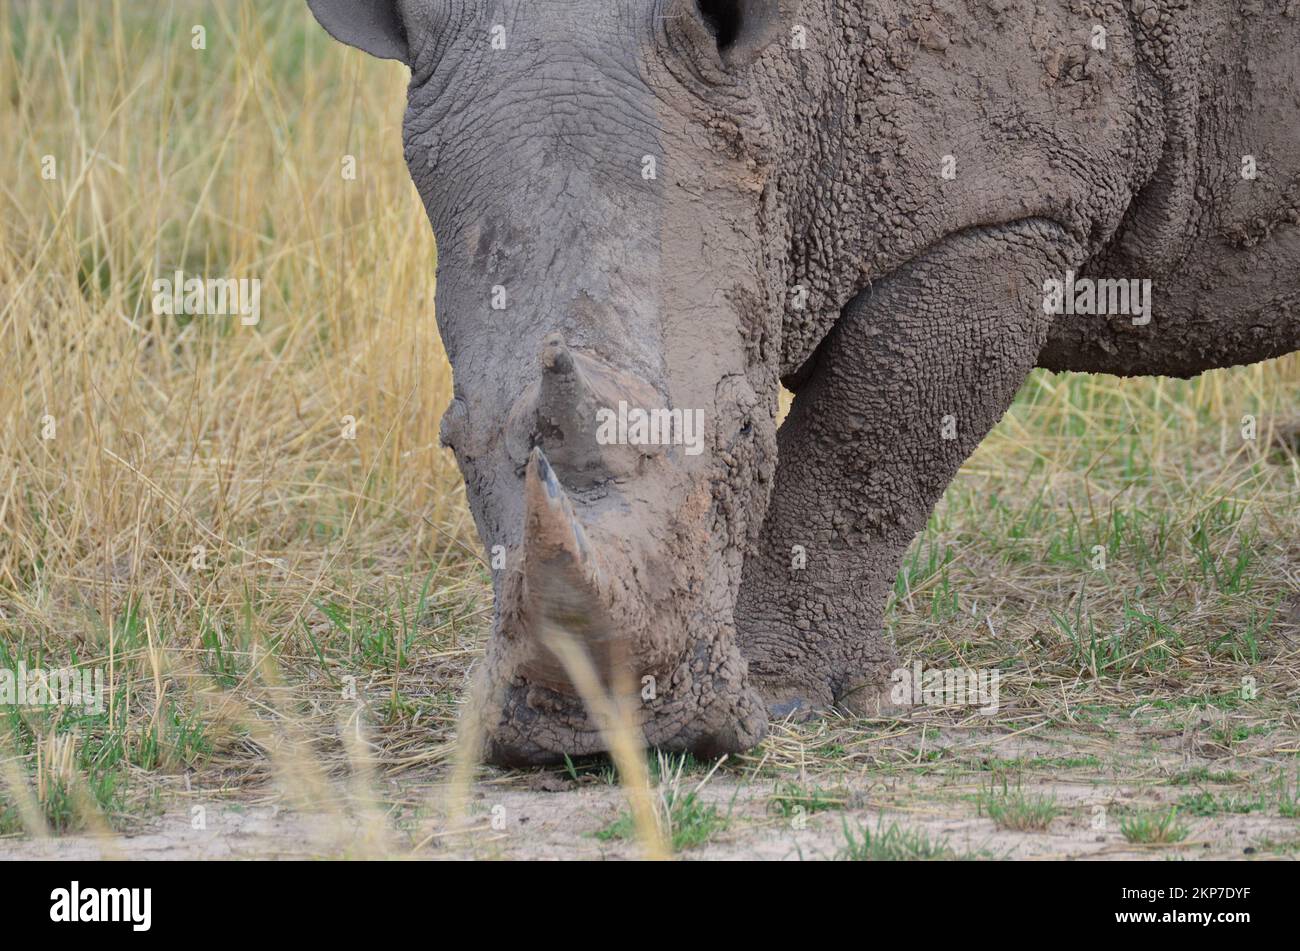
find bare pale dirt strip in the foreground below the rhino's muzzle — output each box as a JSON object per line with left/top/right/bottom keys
{"left": 0, "top": 715, "right": 1300, "bottom": 860}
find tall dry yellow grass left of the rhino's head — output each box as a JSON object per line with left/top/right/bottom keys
{"left": 0, "top": 3, "right": 482, "bottom": 831}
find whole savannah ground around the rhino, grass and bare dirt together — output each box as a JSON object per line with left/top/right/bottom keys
{"left": 0, "top": 0, "right": 1300, "bottom": 859}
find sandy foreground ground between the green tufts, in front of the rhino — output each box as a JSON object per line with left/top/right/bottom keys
{"left": 0, "top": 728, "right": 1300, "bottom": 860}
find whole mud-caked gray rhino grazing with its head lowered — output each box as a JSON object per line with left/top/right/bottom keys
{"left": 309, "top": 0, "right": 1300, "bottom": 764}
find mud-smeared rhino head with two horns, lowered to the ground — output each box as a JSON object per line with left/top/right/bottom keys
{"left": 308, "top": 0, "right": 793, "bottom": 764}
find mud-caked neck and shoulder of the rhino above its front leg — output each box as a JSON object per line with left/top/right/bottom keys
{"left": 755, "top": 0, "right": 1164, "bottom": 378}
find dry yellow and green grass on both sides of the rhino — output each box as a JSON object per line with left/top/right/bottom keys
{"left": 0, "top": 0, "right": 1300, "bottom": 854}
